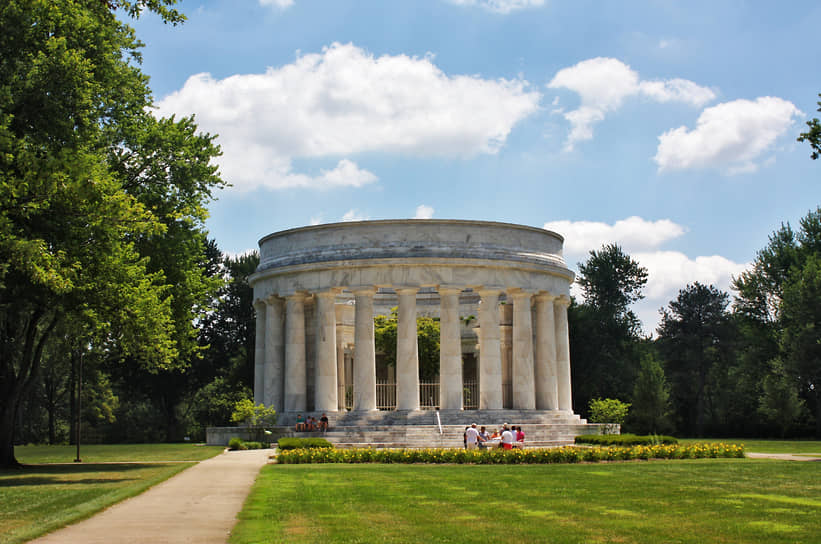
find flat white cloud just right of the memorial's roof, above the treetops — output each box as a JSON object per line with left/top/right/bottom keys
{"left": 544, "top": 216, "right": 686, "bottom": 259}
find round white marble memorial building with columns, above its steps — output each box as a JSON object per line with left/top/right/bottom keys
{"left": 249, "top": 219, "right": 573, "bottom": 413}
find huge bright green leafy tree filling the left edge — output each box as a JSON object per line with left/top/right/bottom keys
{"left": 0, "top": 0, "right": 222, "bottom": 466}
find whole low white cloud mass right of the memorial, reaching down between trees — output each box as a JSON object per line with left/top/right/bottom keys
{"left": 544, "top": 216, "right": 749, "bottom": 334}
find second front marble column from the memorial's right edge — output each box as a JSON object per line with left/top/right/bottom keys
{"left": 534, "top": 293, "right": 559, "bottom": 410}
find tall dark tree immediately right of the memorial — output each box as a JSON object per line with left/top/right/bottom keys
{"left": 568, "top": 244, "right": 647, "bottom": 415}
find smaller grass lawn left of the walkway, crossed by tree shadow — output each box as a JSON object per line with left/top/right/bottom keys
{"left": 0, "top": 444, "right": 222, "bottom": 544}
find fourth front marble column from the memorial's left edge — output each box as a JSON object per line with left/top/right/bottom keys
{"left": 314, "top": 289, "right": 339, "bottom": 412}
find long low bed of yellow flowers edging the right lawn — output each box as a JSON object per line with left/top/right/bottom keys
{"left": 277, "top": 444, "right": 744, "bottom": 465}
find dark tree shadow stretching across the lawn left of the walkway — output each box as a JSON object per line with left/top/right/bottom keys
{"left": 0, "top": 463, "right": 179, "bottom": 487}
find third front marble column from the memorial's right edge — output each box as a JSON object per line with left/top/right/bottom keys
{"left": 508, "top": 289, "right": 536, "bottom": 410}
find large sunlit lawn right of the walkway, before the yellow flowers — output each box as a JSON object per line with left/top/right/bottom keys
{"left": 230, "top": 459, "right": 821, "bottom": 544}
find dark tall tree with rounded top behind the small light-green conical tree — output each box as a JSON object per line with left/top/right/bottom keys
{"left": 657, "top": 282, "right": 733, "bottom": 436}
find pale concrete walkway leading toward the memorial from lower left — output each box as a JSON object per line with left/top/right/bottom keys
{"left": 31, "top": 450, "right": 272, "bottom": 544}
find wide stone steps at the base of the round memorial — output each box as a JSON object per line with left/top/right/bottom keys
{"left": 278, "top": 410, "right": 600, "bottom": 448}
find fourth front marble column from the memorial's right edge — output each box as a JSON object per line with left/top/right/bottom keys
{"left": 477, "top": 288, "right": 502, "bottom": 410}
